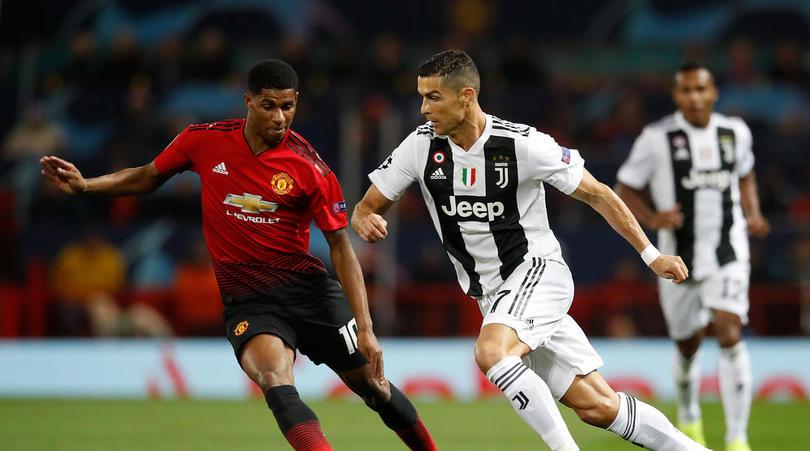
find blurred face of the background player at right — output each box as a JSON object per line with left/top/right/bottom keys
{"left": 672, "top": 68, "right": 717, "bottom": 127}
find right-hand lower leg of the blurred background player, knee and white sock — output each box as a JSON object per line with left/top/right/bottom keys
{"left": 712, "top": 310, "right": 752, "bottom": 451}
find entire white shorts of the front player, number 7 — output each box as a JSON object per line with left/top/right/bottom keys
{"left": 478, "top": 257, "right": 604, "bottom": 400}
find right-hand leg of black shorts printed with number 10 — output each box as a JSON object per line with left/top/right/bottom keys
{"left": 296, "top": 279, "right": 366, "bottom": 372}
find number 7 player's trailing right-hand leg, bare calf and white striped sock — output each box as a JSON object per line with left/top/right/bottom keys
{"left": 560, "top": 371, "right": 706, "bottom": 451}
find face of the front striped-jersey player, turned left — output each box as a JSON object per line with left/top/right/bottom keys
{"left": 417, "top": 76, "right": 465, "bottom": 136}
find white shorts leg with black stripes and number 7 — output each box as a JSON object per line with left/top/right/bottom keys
{"left": 478, "top": 257, "right": 574, "bottom": 349}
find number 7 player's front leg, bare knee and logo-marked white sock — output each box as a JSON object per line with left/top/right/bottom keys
{"left": 475, "top": 323, "right": 579, "bottom": 451}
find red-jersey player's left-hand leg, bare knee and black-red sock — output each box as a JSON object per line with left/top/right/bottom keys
{"left": 239, "top": 334, "right": 332, "bottom": 451}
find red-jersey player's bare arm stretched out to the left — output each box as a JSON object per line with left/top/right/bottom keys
{"left": 39, "top": 157, "right": 169, "bottom": 196}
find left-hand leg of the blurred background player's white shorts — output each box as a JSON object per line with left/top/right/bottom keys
{"left": 658, "top": 279, "right": 710, "bottom": 341}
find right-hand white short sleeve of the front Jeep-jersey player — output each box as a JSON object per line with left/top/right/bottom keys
{"left": 529, "top": 129, "right": 585, "bottom": 194}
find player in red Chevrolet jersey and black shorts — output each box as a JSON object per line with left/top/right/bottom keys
{"left": 40, "top": 60, "right": 436, "bottom": 450}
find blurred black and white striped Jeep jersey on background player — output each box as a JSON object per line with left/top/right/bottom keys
{"left": 617, "top": 112, "right": 754, "bottom": 280}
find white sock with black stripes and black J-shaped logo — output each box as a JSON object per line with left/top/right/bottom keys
{"left": 487, "top": 356, "right": 579, "bottom": 451}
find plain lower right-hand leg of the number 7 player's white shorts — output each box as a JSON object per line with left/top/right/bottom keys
{"left": 523, "top": 315, "right": 604, "bottom": 400}
